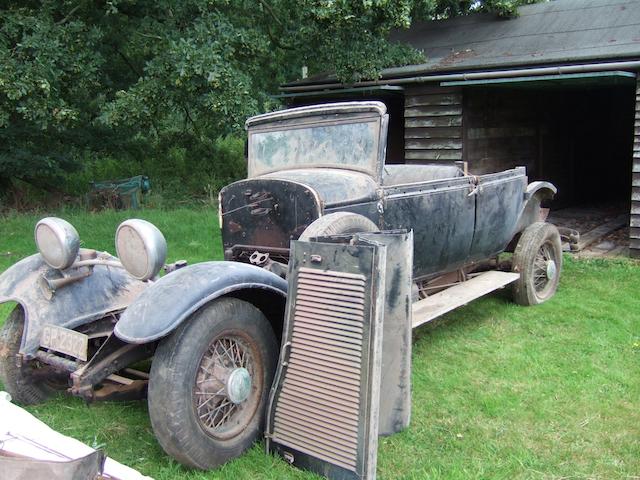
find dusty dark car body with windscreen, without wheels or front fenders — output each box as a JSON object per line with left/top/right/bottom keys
{"left": 220, "top": 102, "right": 556, "bottom": 279}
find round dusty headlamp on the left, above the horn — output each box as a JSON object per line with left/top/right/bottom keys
{"left": 34, "top": 217, "right": 80, "bottom": 270}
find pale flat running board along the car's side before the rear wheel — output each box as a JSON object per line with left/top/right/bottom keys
{"left": 412, "top": 270, "right": 520, "bottom": 328}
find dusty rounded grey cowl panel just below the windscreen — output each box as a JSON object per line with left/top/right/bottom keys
{"left": 256, "top": 168, "right": 377, "bottom": 207}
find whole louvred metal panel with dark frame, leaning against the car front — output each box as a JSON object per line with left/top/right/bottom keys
{"left": 267, "top": 240, "right": 386, "bottom": 479}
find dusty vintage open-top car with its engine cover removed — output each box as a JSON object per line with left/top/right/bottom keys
{"left": 0, "top": 102, "right": 562, "bottom": 469}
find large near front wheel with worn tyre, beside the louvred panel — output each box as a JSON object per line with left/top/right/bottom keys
{"left": 148, "top": 297, "right": 278, "bottom": 470}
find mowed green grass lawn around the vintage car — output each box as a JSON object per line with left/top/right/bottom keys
{"left": 0, "top": 209, "right": 640, "bottom": 480}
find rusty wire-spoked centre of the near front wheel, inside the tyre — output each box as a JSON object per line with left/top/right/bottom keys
{"left": 193, "top": 334, "right": 262, "bottom": 439}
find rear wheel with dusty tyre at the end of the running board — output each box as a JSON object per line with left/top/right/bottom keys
{"left": 513, "top": 222, "right": 562, "bottom": 306}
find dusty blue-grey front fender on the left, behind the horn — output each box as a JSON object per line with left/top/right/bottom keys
{"left": 0, "top": 253, "right": 147, "bottom": 358}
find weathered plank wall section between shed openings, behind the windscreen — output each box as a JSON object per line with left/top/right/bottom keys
{"left": 404, "top": 86, "right": 462, "bottom": 164}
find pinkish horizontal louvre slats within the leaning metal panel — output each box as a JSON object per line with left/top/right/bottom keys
{"left": 272, "top": 268, "right": 367, "bottom": 472}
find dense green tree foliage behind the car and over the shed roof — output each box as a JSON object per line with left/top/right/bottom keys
{"left": 0, "top": 0, "right": 531, "bottom": 204}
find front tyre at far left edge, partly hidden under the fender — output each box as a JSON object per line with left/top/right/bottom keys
{"left": 0, "top": 306, "right": 66, "bottom": 405}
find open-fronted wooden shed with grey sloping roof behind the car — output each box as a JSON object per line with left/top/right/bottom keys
{"left": 282, "top": 0, "right": 640, "bottom": 257}
